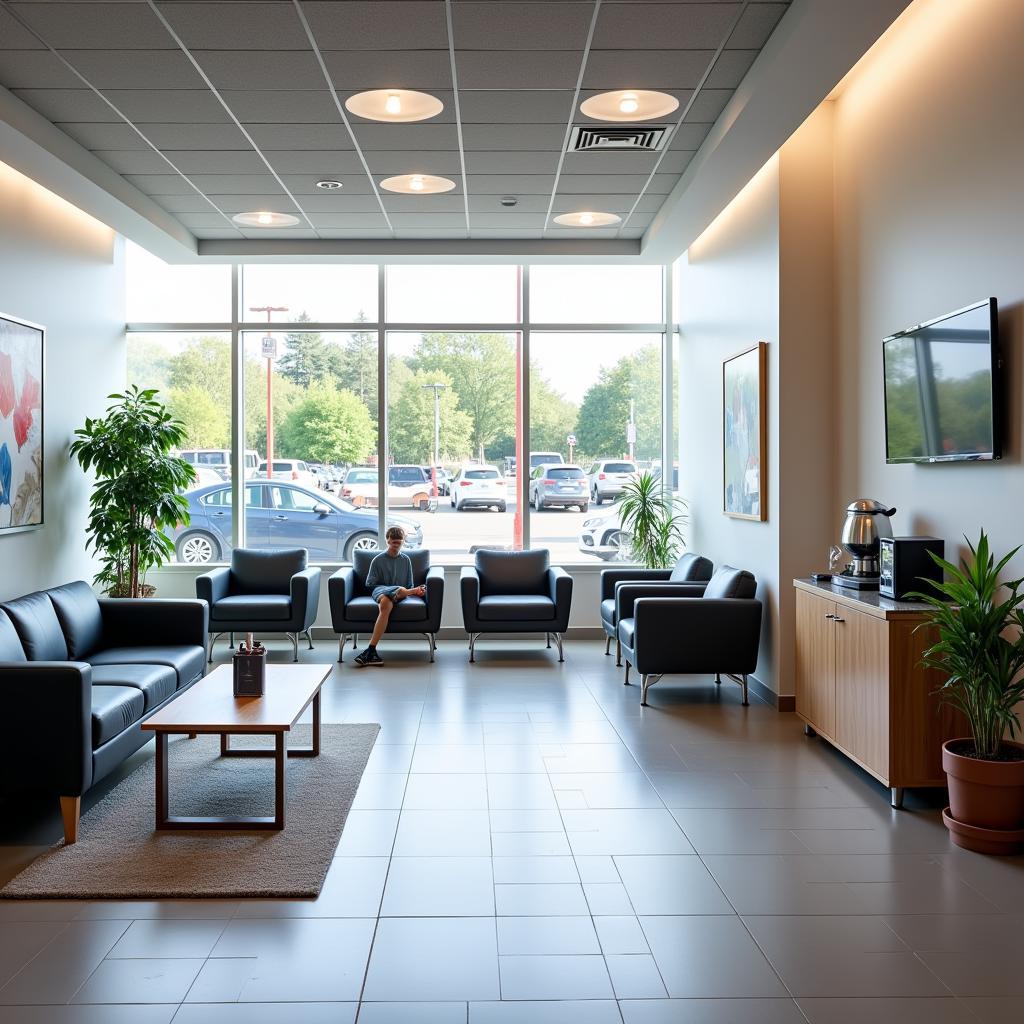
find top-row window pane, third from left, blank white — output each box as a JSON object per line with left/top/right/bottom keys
{"left": 387, "top": 265, "right": 520, "bottom": 324}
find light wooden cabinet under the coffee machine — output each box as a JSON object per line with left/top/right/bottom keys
{"left": 794, "top": 580, "right": 967, "bottom": 807}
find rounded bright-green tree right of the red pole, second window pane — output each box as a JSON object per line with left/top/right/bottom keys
{"left": 275, "top": 381, "right": 376, "bottom": 462}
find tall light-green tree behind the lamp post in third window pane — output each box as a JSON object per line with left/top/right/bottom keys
{"left": 410, "top": 332, "right": 515, "bottom": 457}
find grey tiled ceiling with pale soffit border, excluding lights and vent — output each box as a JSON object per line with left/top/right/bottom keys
{"left": 0, "top": 0, "right": 905, "bottom": 261}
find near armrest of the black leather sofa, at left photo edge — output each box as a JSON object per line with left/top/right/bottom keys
{"left": 0, "top": 662, "right": 92, "bottom": 797}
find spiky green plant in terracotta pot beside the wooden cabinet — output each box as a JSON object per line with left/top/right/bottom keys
{"left": 913, "top": 530, "right": 1024, "bottom": 853}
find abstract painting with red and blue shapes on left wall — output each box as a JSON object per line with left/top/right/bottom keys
{"left": 0, "top": 313, "right": 46, "bottom": 537}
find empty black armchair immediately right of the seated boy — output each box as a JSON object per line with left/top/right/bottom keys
{"left": 460, "top": 551, "right": 572, "bottom": 662}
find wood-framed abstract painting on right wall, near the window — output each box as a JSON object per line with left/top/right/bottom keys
{"left": 722, "top": 341, "right": 768, "bottom": 522}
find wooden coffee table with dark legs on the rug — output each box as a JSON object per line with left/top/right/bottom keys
{"left": 142, "top": 665, "right": 331, "bottom": 829}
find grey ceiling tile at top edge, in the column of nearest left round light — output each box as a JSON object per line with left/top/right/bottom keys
{"left": 302, "top": 0, "right": 447, "bottom": 50}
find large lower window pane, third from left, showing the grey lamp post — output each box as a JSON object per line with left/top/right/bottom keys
{"left": 387, "top": 331, "right": 522, "bottom": 564}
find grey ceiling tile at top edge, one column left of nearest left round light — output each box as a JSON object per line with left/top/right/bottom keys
{"left": 160, "top": 0, "right": 309, "bottom": 50}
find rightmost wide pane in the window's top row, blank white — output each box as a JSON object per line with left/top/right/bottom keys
{"left": 529, "top": 264, "right": 663, "bottom": 324}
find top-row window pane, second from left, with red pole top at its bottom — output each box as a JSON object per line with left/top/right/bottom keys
{"left": 240, "top": 263, "right": 377, "bottom": 324}
